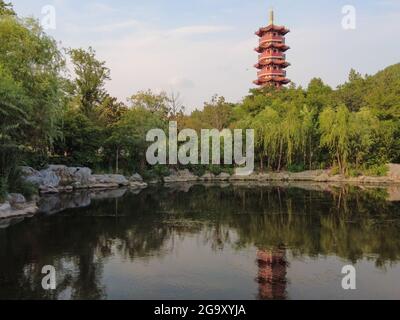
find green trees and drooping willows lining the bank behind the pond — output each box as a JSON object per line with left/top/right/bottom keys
{"left": 0, "top": 0, "right": 400, "bottom": 200}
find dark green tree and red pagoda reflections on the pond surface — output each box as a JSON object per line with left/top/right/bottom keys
{"left": 0, "top": 185, "right": 400, "bottom": 299}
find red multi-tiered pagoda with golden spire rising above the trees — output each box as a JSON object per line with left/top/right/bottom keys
{"left": 254, "top": 10, "right": 290, "bottom": 88}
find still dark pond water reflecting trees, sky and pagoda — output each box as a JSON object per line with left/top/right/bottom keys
{"left": 0, "top": 184, "right": 400, "bottom": 299}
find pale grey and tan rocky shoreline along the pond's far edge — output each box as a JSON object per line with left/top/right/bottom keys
{"left": 0, "top": 164, "right": 400, "bottom": 219}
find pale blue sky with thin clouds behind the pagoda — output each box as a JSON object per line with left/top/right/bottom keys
{"left": 10, "top": 0, "right": 400, "bottom": 111}
